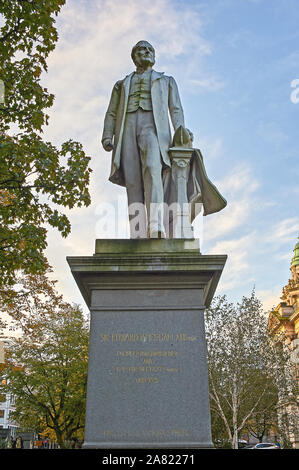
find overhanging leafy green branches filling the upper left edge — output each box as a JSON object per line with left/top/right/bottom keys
{"left": 0, "top": 0, "right": 91, "bottom": 297}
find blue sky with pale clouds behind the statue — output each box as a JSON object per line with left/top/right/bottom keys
{"left": 33, "top": 0, "right": 299, "bottom": 316}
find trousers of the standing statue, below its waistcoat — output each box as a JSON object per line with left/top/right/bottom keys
{"left": 121, "top": 108, "right": 164, "bottom": 238}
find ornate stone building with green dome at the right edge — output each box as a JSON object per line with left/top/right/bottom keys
{"left": 268, "top": 242, "right": 299, "bottom": 448}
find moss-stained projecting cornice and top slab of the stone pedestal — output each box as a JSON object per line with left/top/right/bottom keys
{"left": 67, "top": 240, "right": 227, "bottom": 308}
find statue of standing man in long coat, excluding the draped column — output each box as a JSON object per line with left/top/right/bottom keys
{"left": 102, "top": 41, "right": 191, "bottom": 238}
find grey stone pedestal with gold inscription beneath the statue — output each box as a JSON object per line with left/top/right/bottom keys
{"left": 67, "top": 239, "right": 226, "bottom": 449}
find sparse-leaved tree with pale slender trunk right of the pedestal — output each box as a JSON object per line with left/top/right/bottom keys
{"left": 206, "top": 292, "right": 294, "bottom": 449}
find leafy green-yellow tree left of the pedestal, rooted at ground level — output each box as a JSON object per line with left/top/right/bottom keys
{"left": 2, "top": 274, "right": 89, "bottom": 447}
